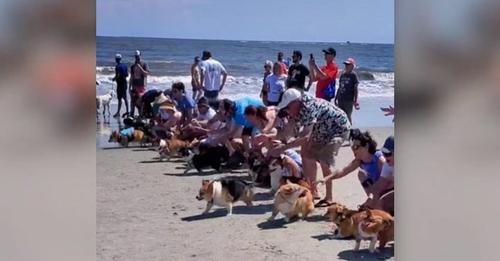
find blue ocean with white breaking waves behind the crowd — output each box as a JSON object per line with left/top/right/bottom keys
{"left": 96, "top": 36, "right": 394, "bottom": 127}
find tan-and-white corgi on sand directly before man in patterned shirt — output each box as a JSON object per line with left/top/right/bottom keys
{"left": 268, "top": 180, "right": 314, "bottom": 222}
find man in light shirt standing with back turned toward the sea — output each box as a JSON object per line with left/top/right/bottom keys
{"left": 200, "top": 51, "right": 227, "bottom": 109}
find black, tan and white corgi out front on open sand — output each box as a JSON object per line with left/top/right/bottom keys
{"left": 196, "top": 178, "right": 253, "bottom": 215}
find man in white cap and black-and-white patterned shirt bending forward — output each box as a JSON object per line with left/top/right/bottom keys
{"left": 270, "top": 89, "right": 351, "bottom": 207}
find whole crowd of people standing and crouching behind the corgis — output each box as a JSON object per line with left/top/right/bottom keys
{"left": 110, "top": 47, "right": 394, "bottom": 208}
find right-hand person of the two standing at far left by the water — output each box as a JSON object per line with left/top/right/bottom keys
{"left": 129, "top": 50, "right": 149, "bottom": 117}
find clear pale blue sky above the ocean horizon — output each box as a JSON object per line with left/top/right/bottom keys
{"left": 96, "top": 0, "right": 394, "bottom": 43}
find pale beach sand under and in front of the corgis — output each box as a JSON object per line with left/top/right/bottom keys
{"left": 96, "top": 125, "right": 394, "bottom": 260}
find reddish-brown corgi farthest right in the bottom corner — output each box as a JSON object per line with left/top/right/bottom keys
{"left": 354, "top": 209, "right": 394, "bottom": 253}
